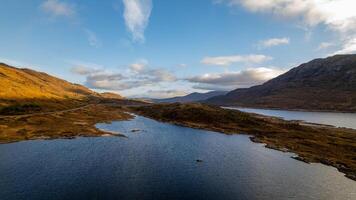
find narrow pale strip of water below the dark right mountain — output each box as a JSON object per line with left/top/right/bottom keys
{"left": 226, "top": 107, "right": 356, "bottom": 129}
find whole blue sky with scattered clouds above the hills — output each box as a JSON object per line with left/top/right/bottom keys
{"left": 0, "top": 0, "right": 356, "bottom": 98}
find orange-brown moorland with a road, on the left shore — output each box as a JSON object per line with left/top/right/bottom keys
{"left": 0, "top": 104, "right": 132, "bottom": 143}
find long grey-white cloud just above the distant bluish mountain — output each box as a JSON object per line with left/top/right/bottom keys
{"left": 186, "top": 67, "right": 285, "bottom": 90}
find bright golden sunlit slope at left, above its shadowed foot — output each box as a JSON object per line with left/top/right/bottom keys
{"left": 0, "top": 64, "right": 97, "bottom": 100}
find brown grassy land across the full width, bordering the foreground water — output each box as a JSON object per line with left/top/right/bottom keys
{"left": 0, "top": 103, "right": 356, "bottom": 181}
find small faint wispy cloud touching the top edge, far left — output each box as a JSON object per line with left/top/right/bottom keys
{"left": 40, "top": 0, "right": 76, "bottom": 17}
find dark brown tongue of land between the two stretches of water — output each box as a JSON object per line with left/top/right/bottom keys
{"left": 131, "top": 103, "right": 356, "bottom": 180}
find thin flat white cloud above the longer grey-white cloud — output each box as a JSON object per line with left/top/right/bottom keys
{"left": 201, "top": 54, "right": 272, "bottom": 66}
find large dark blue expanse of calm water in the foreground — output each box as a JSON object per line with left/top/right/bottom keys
{"left": 0, "top": 117, "right": 356, "bottom": 200}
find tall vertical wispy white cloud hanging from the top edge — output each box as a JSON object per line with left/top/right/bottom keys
{"left": 123, "top": 0, "right": 152, "bottom": 42}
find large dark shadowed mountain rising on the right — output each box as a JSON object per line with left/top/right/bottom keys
{"left": 205, "top": 54, "right": 356, "bottom": 112}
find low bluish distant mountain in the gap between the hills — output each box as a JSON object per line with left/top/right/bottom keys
{"left": 153, "top": 91, "right": 227, "bottom": 103}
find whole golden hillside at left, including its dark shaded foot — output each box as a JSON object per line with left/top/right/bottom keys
{"left": 0, "top": 63, "right": 98, "bottom": 110}
